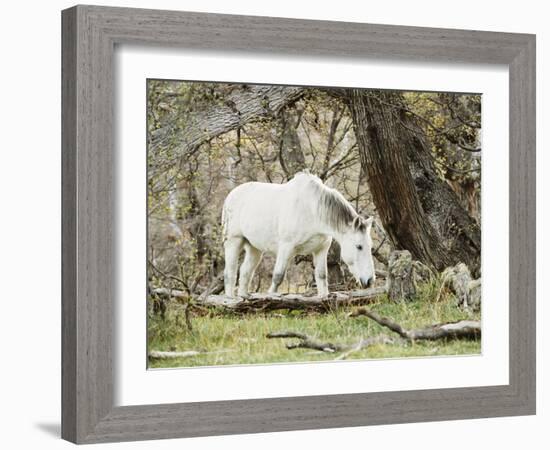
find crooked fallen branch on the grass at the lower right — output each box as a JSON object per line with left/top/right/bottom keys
{"left": 349, "top": 308, "right": 481, "bottom": 341}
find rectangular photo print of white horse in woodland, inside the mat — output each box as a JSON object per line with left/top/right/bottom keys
{"left": 146, "top": 79, "right": 482, "bottom": 368}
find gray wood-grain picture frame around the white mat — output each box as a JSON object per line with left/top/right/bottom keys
{"left": 62, "top": 6, "right": 535, "bottom": 443}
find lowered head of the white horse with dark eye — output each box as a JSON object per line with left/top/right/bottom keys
{"left": 340, "top": 216, "right": 376, "bottom": 287}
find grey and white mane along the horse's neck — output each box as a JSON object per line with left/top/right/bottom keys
{"left": 295, "top": 172, "right": 359, "bottom": 232}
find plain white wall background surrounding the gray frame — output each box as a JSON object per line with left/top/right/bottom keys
{"left": 0, "top": 0, "right": 550, "bottom": 450}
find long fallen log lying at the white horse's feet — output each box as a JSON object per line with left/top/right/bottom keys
{"left": 151, "top": 286, "right": 386, "bottom": 313}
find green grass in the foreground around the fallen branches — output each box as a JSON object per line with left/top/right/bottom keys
{"left": 148, "top": 283, "right": 481, "bottom": 368}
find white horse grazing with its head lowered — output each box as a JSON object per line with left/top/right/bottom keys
{"left": 222, "top": 172, "right": 375, "bottom": 297}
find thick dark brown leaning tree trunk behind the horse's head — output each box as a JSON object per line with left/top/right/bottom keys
{"left": 347, "top": 89, "right": 481, "bottom": 276}
